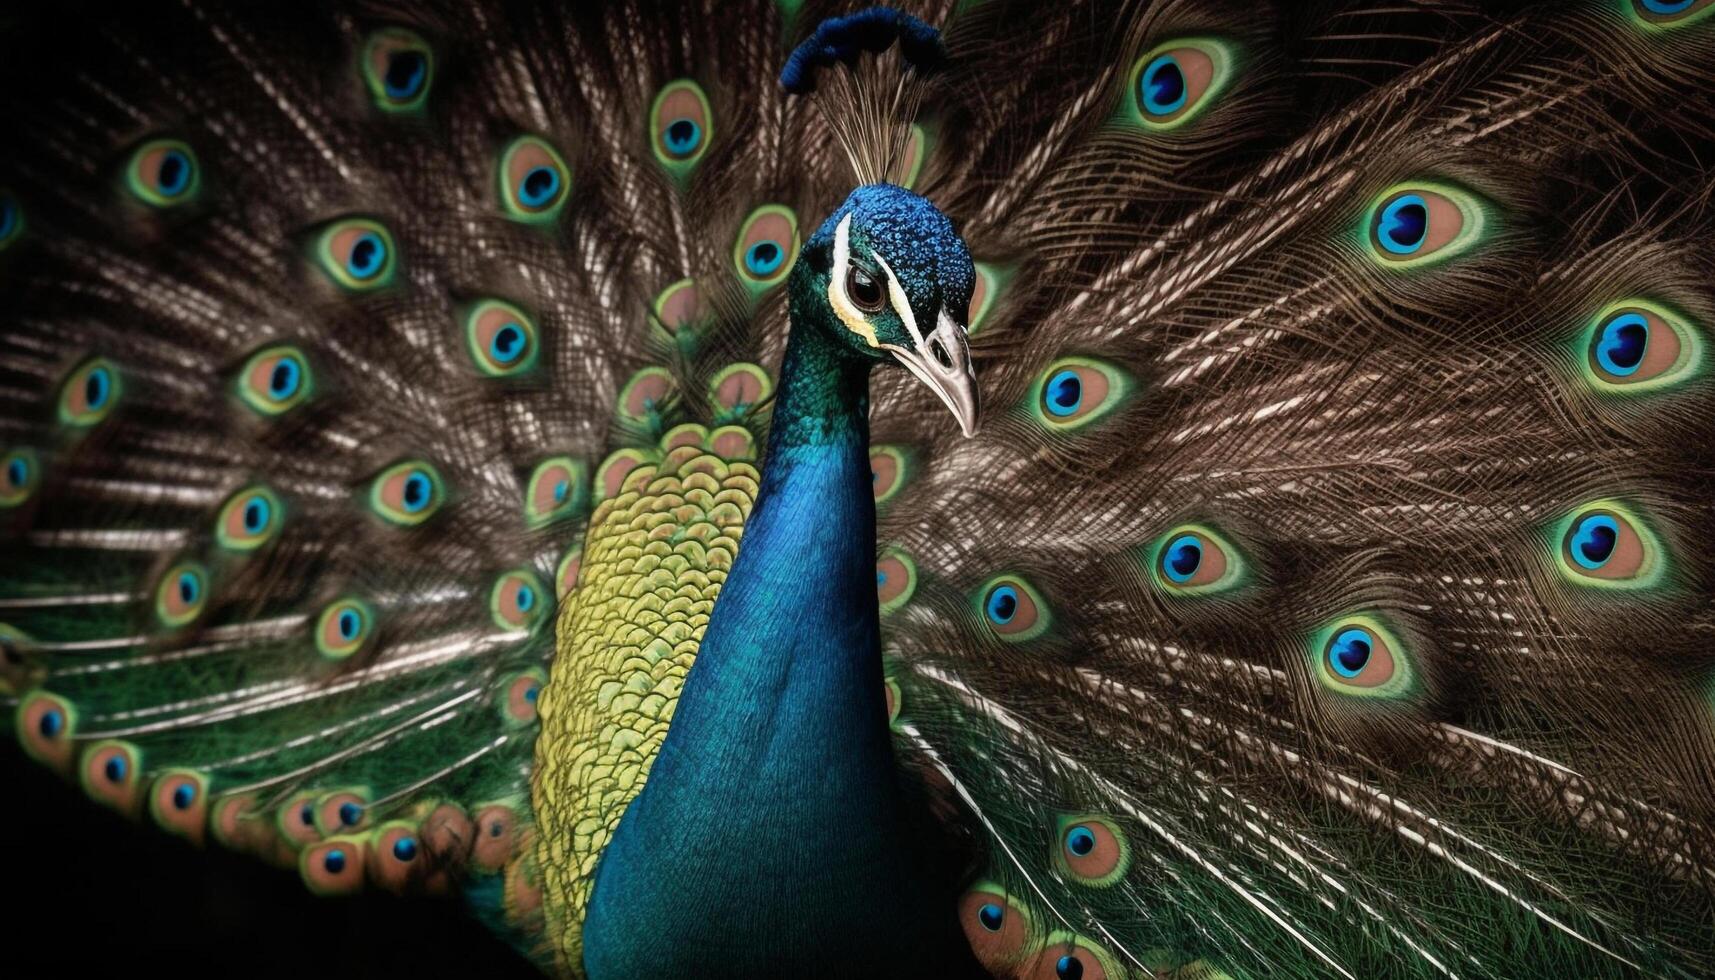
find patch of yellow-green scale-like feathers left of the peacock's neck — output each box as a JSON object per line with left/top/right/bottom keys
{"left": 532, "top": 446, "right": 760, "bottom": 973}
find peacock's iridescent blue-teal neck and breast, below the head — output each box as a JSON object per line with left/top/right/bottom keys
{"left": 583, "top": 296, "right": 971, "bottom": 977}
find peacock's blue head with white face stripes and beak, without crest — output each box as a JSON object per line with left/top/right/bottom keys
{"left": 791, "top": 184, "right": 978, "bottom": 436}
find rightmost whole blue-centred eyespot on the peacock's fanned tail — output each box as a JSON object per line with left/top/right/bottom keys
{"left": 1585, "top": 300, "right": 1703, "bottom": 395}
